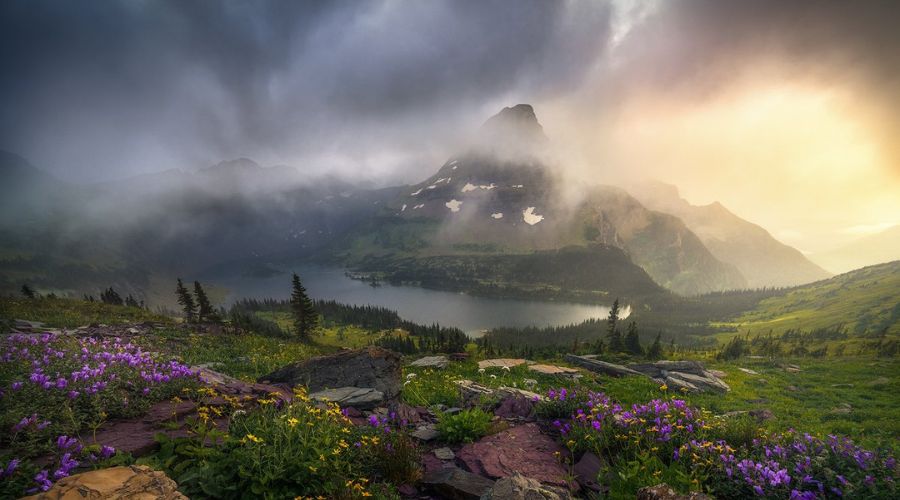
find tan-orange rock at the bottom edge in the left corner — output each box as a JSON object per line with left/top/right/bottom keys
{"left": 25, "top": 465, "right": 187, "bottom": 500}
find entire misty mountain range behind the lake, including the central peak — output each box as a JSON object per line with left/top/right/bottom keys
{"left": 0, "top": 105, "right": 884, "bottom": 304}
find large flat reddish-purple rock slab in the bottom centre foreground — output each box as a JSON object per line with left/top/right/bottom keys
{"left": 456, "top": 423, "right": 568, "bottom": 487}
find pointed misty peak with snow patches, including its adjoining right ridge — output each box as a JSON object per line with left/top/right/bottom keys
{"left": 333, "top": 105, "right": 746, "bottom": 294}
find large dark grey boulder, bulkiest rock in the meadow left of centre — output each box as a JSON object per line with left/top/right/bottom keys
{"left": 260, "top": 346, "right": 402, "bottom": 400}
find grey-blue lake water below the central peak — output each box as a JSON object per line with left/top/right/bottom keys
{"left": 214, "top": 267, "right": 627, "bottom": 336}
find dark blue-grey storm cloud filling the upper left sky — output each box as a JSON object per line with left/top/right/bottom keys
{"left": 0, "top": 1, "right": 609, "bottom": 182}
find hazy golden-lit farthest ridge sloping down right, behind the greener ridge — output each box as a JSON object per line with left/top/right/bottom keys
{"left": 629, "top": 182, "right": 830, "bottom": 288}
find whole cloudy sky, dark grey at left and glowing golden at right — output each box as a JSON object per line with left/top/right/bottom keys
{"left": 0, "top": 0, "right": 900, "bottom": 251}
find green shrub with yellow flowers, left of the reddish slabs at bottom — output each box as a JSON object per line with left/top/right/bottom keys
{"left": 151, "top": 392, "right": 408, "bottom": 499}
